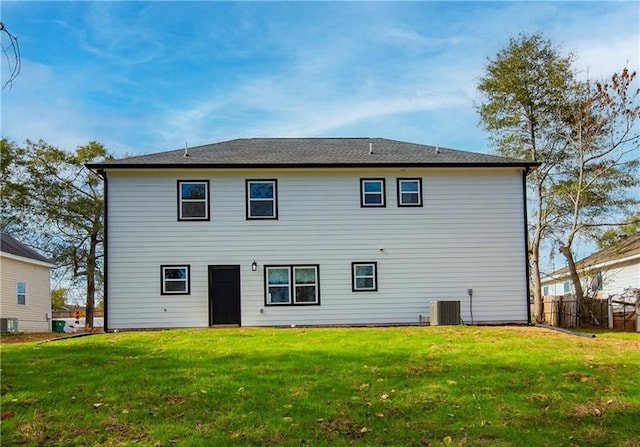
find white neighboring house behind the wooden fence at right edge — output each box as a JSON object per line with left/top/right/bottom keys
{"left": 542, "top": 233, "right": 640, "bottom": 298}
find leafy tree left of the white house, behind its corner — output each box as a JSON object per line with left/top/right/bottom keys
{"left": 0, "top": 139, "right": 110, "bottom": 329}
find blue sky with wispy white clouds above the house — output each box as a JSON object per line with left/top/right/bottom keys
{"left": 1, "top": 1, "right": 640, "bottom": 155}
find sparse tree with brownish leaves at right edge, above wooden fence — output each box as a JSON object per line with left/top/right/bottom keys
{"left": 551, "top": 68, "right": 640, "bottom": 322}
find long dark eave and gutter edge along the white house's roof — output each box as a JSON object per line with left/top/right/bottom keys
{"left": 86, "top": 161, "right": 540, "bottom": 171}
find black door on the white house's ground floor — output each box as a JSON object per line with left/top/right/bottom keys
{"left": 209, "top": 265, "right": 240, "bottom": 326}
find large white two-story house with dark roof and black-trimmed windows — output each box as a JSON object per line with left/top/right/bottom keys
{"left": 88, "top": 138, "right": 537, "bottom": 330}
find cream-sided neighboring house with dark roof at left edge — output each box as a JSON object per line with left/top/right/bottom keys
{"left": 0, "top": 233, "right": 55, "bottom": 332}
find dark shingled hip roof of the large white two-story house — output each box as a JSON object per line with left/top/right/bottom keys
{"left": 88, "top": 138, "right": 539, "bottom": 169}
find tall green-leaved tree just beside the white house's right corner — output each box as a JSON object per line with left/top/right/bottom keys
{"left": 477, "top": 34, "right": 576, "bottom": 322}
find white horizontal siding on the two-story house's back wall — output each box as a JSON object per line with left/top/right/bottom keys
{"left": 108, "top": 168, "right": 527, "bottom": 329}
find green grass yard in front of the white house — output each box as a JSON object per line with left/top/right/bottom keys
{"left": 1, "top": 326, "right": 640, "bottom": 447}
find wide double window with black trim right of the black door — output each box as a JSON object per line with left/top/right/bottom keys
{"left": 265, "top": 265, "right": 320, "bottom": 306}
